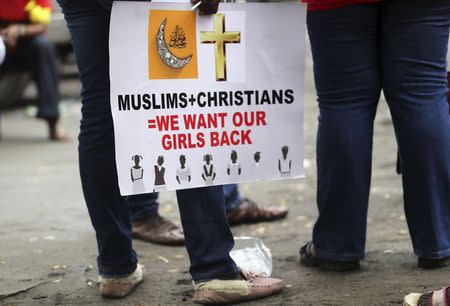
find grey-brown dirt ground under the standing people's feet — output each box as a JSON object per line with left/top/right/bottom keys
{"left": 0, "top": 44, "right": 450, "bottom": 306}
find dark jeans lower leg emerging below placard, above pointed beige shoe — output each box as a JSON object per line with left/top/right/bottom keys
{"left": 177, "top": 186, "right": 238, "bottom": 282}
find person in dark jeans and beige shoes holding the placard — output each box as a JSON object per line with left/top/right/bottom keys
{"left": 58, "top": 0, "right": 284, "bottom": 303}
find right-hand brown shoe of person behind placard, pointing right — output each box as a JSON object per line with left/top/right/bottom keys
{"left": 227, "top": 199, "right": 288, "bottom": 225}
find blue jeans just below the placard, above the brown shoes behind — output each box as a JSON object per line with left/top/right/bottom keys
{"left": 128, "top": 184, "right": 242, "bottom": 222}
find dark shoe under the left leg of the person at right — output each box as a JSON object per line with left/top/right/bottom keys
{"left": 300, "top": 241, "right": 361, "bottom": 272}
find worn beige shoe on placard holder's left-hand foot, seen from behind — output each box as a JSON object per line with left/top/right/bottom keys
{"left": 99, "top": 264, "right": 144, "bottom": 299}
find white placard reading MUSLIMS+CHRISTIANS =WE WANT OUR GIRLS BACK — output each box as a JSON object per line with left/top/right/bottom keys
{"left": 110, "top": 2, "right": 306, "bottom": 195}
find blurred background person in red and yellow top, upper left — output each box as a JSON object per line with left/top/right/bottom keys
{"left": 0, "top": 0, "right": 68, "bottom": 141}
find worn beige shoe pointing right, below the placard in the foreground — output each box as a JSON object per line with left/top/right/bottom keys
{"left": 193, "top": 270, "right": 284, "bottom": 304}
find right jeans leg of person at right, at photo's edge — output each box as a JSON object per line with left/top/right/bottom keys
{"left": 382, "top": 0, "right": 450, "bottom": 259}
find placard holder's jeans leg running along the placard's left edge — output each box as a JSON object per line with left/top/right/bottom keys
{"left": 61, "top": 0, "right": 137, "bottom": 275}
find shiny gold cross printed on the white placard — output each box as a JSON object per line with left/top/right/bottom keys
{"left": 200, "top": 14, "right": 241, "bottom": 81}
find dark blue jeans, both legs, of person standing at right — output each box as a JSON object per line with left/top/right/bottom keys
{"left": 307, "top": 0, "right": 450, "bottom": 261}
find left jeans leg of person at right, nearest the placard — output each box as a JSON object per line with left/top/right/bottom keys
{"left": 307, "top": 5, "right": 380, "bottom": 261}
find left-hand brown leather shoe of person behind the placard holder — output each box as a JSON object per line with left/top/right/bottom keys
{"left": 132, "top": 212, "right": 185, "bottom": 245}
